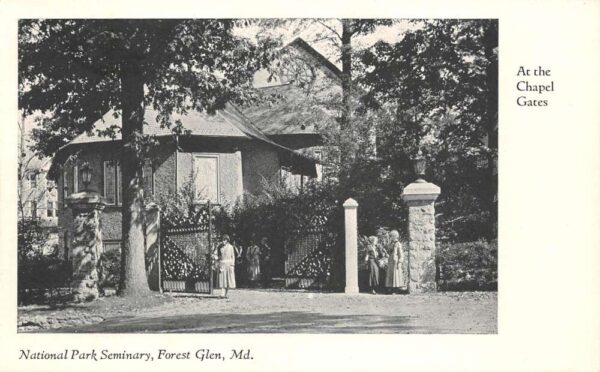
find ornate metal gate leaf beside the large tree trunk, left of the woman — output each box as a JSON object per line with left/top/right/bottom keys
{"left": 159, "top": 203, "right": 214, "bottom": 293}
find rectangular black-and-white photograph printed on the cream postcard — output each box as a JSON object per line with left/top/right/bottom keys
{"left": 18, "top": 18, "right": 498, "bottom": 334}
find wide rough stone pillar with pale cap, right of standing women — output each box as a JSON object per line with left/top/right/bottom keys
{"left": 402, "top": 179, "right": 441, "bottom": 293}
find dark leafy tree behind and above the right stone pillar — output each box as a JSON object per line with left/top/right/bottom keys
{"left": 361, "top": 20, "right": 498, "bottom": 240}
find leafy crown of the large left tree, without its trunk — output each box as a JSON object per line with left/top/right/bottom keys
{"left": 19, "top": 19, "right": 276, "bottom": 155}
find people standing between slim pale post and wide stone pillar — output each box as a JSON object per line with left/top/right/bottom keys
{"left": 365, "top": 230, "right": 406, "bottom": 294}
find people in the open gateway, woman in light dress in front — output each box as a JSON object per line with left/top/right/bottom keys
{"left": 216, "top": 234, "right": 270, "bottom": 298}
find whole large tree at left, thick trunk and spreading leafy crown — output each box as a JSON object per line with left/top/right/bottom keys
{"left": 19, "top": 19, "right": 273, "bottom": 296}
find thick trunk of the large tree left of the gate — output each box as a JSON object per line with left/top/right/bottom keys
{"left": 119, "top": 59, "right": 150, "bottom": 296}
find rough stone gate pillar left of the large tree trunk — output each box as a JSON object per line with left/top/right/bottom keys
{"left": 67, "top": 191, "right": 106, "bottom": 302}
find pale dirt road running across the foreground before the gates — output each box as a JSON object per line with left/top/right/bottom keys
{"left": 25, "top": 289, "right": 497, "bottom": 333}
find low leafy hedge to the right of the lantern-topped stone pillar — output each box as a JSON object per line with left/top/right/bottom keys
{"left": 436, "top": 240, "right": 498, "bottom": 291}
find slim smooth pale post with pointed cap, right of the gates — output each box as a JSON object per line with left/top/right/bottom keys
{"left": 344, "top": 198, "right": 358, "bottom": 293}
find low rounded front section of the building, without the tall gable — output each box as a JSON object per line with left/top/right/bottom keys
{"left": 54, "top": 101, "right": 316, "bottom": 256}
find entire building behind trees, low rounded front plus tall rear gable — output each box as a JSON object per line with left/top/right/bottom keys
{"left": 51, "top": 39, "right": 341, "bottom": 258}
